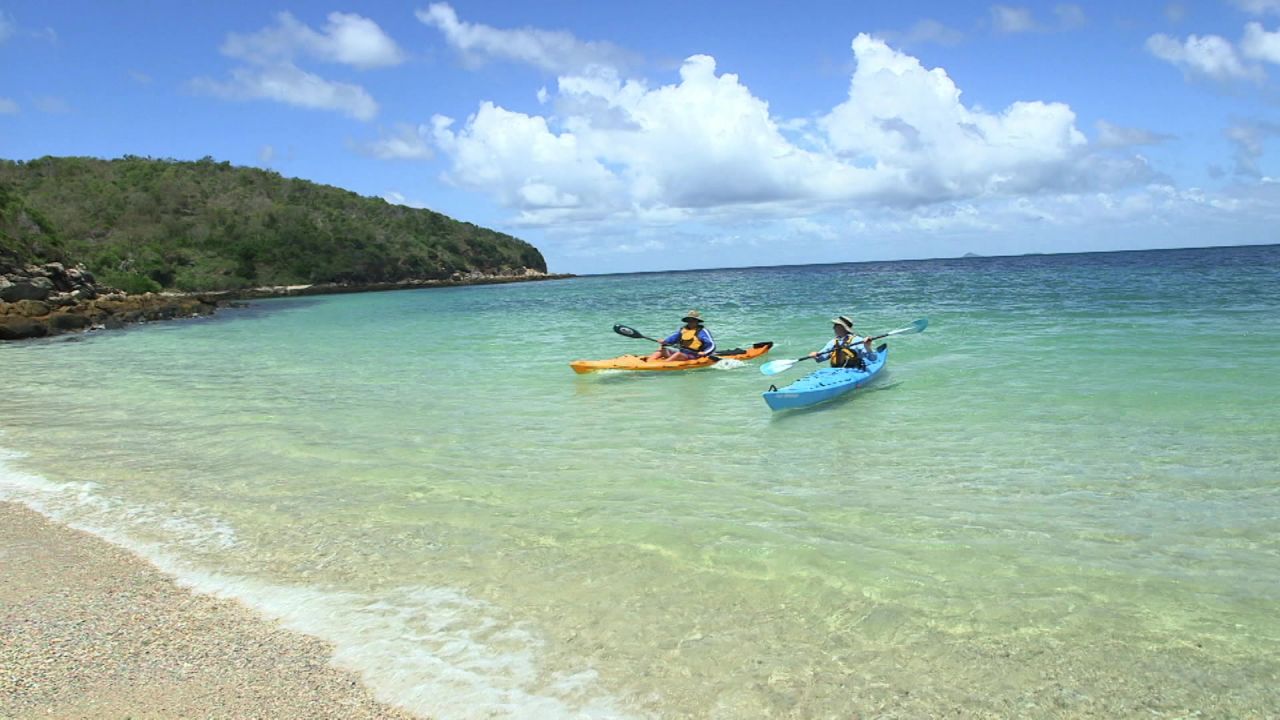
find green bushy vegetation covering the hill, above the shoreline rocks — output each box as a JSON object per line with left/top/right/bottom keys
{"left": 0, "top": 156, "right": 547, "bottom": 292}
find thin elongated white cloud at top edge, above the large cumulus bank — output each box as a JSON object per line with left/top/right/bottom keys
{"left": 415, "top": 3, "right": 628, "bottom": 73}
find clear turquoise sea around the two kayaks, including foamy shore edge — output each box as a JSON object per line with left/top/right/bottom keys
{"left": 0, "top": 246, "right": 1280, "bottom": 719}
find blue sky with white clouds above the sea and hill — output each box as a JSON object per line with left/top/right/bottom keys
{"left": 0, "top": 0, "right": 1280, "bottom": 274}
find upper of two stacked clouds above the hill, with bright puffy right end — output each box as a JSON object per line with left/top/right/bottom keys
{"left": 221, "top": 13, "right": 404, "bottom": 69}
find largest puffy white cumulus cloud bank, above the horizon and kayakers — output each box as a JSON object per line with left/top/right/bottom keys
{"left": 431, "top": 35, "right": 1153, "bottom": 224}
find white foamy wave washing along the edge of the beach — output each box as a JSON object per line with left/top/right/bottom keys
{"left": 0, "top": 448, "right": 636, "bottom": 717}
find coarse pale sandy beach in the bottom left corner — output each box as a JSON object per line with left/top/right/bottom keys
{"left": 0, "top": 502, "right": 412, "bottom": 720}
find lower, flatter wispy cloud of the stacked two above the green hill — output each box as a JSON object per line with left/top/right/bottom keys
{"left": 192, "top": 65, "right": 378, "bottom": 120}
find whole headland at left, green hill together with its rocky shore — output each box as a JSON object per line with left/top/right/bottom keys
{"left": 0, "top": 156, "right": 563, "bottom": 340}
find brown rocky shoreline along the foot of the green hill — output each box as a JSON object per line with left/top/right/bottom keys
{"left": 0, "top": 263, "right": 573, "bottom": 341}
